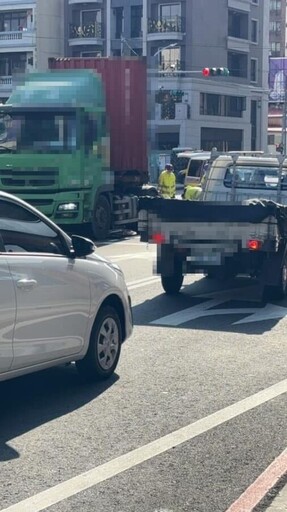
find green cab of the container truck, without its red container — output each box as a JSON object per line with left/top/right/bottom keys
{"left": 0, "top": 61, "right": 153, "bottom": 239}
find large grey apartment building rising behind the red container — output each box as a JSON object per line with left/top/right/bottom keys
{"left": 67, "top": 0, "right": 272, "bottom": 174}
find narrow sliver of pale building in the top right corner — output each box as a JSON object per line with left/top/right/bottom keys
{"left": 269, "top": 0, "right": 287, "bottom": 57}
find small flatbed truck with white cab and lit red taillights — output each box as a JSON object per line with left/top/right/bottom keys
{"left": 139, "top": 152, "right": 287, "bottom": 300}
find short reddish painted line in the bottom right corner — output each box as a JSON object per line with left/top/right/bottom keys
{"left": 226, "top": 449, "right": 287, "bottom": 512}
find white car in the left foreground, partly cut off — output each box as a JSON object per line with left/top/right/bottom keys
{"left": 0, "top": 192, "right": 132, "bottom": 381}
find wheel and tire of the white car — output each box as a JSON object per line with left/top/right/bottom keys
{"left": 76, "top": 306, "right": 122, "bottom": 381}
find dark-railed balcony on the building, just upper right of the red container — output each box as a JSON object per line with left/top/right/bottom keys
{"left": 147, "top": 16, "right": 185, "bottom": 41}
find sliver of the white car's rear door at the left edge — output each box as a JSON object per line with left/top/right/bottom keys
{"left": 0, "top": 253, "right": 16, "bottom": 375}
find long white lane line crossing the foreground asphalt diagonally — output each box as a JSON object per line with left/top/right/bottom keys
{"left": 0, "top": 379, "right": 287, "bottom": 512}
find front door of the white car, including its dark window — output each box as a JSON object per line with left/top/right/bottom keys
{"left": 0, "top": 199, "right": 91, "bottom": 369}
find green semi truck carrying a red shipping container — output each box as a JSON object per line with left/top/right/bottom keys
{"left": 0, "top": 57, "right": 156, "bottom": 239}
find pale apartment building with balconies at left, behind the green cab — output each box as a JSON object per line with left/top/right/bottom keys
{"left": 0, "top": 0, "right": 66, "bottom": 103}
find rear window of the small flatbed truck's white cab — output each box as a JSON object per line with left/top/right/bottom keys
{"left": 224, "top": 166, "right": 287, "bottom": 190}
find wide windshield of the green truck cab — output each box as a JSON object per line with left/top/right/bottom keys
{"left": 0, "top": 111, "right": 76, "bottom": 153}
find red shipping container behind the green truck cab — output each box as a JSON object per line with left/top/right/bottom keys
{"left": 49, "top": 57, "right": 148, "bottom": 183}
